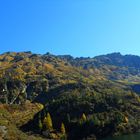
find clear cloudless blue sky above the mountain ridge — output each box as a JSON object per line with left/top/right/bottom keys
{"left": 0, "top": 0, "right": 140, "bottom": 56}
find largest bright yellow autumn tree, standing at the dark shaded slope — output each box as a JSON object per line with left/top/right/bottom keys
{"left": 43, "top": 113, "right": 53, "bottom": 130}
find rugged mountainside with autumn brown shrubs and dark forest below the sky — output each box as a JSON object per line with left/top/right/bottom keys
{"left": 0, "top": 52, "right": 140, "bottom": 140}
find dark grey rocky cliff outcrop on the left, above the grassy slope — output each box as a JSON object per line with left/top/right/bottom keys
{"left": 0, "top": 81, "right": 48, "bottom": 104}
